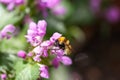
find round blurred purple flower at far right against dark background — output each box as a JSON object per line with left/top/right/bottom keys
{"left": 105, "top": 6, "right": 120, "bottom": 22}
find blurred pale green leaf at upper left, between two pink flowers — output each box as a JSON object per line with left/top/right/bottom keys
{"left": 0, "top": 4, "right": 23, "bottom": 29}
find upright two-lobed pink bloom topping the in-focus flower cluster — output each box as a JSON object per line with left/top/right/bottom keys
{"left": 25, "top": 20, "right": 47, "bottom": 46}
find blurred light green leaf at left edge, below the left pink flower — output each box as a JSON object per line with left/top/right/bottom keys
{"left": 0, "top": 37, "right": 26, "bottom": 54}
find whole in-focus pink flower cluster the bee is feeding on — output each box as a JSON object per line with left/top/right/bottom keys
{"left": 18, "top": 20, "right": 72, "bottom": 78}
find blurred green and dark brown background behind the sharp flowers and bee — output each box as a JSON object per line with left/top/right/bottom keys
{"left": 0, "top": 0, "right": 120, "bottom": 80}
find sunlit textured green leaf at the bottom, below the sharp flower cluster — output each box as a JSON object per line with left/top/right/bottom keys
{"left": 15, "top": 62, "right": 39, "bottom": 80}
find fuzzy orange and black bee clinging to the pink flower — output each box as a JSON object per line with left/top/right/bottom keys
{"left": 54, "top": 36, "right": 72, "bottom": 55}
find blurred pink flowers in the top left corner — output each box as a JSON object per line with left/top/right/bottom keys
{"left": 0, "top": 0, "right": 24, "bottom": 11}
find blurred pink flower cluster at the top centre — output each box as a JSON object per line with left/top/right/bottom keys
{"left": 36, "top": 0, "right": 66, "bottom": 16}
